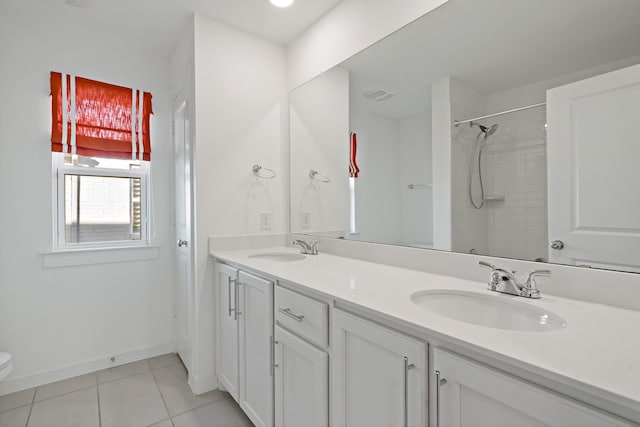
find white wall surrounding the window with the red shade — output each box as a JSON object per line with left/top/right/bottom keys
{"left": 0, "top": 4, "right": 174, "bottom": 394}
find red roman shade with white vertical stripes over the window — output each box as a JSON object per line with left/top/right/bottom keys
{"left": 51, "top": 71, "right": 153, "bottom": 160}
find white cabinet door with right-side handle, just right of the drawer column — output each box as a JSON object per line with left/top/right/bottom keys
{"left": 331, "top": 310, "right": 427, "bottom": 427}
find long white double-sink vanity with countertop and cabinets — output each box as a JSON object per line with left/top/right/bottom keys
{"left": 211, "top": 247, "right": 640, "bottom": 427}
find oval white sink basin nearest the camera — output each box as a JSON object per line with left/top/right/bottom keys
{"left": 411, "top": 290, "right": 567, "bottom": 332}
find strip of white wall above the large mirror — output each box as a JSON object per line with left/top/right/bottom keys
{"left": 287, "top": 0, "right": 448, "bottom": 89}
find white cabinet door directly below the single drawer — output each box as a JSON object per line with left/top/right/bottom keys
{"left": 274, "top": 326, "right": 329, "bottom": 427}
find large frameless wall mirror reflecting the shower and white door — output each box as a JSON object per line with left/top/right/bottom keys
{"left": 290, "top": 0, "right": 640, "bottom": 272}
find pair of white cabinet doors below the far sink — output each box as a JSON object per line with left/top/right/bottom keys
{"left": 217, "top": 263, "right": 273, "bottom": 427}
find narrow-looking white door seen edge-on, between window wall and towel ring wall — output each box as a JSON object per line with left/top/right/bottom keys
{"left": 173, "top": 97, "right": 193, "bottom": 370}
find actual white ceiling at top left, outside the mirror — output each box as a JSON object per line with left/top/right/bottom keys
{"left": 0, "top": 0, "right": 342, "bottom": 55}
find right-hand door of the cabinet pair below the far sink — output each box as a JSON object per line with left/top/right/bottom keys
{"left": 238, "top": 271, "right": 273, "bottom": 427}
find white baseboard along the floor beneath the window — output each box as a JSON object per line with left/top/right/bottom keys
{"left": 0, "top": 341, "right": 175, "bottom": 396}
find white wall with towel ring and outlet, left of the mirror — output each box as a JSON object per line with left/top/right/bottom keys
{"left": 193, "top": 16, "right": 289, "bottom": 388}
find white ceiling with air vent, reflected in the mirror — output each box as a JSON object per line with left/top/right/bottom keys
{"left": 342, "top": 0, "right": 640, "bottom": 118}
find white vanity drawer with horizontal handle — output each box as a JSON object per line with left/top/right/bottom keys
{"left": 274, "top": 286, "right": 329, "bottom": 347}
